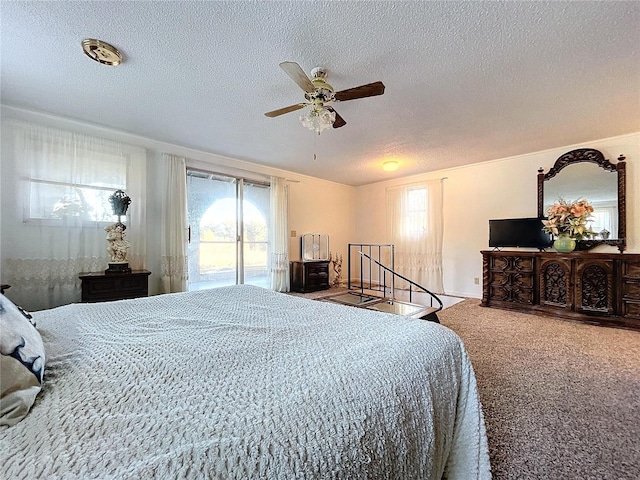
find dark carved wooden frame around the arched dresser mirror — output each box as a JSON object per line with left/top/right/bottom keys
{"left": 538, "top": 148, "right": 627, "bottom": 253}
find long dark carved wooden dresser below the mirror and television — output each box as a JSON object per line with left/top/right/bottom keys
{"left": 481, "top": 251, "right": 640, "bottom": 330}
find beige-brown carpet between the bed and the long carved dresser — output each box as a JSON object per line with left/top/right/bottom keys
{"left": 438, "top": 299, "right": 640, "bottom": 480}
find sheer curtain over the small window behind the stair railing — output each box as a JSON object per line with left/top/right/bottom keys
{"left": 386, "top": 180, "right": 444, "bottom": 293}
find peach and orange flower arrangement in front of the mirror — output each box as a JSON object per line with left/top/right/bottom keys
{"left": 542, "top": 198, "right": 594, "bottom": 240}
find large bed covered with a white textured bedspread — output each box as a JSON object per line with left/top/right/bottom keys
{"left": 0, "top": 285, "right": 491, "bottom": 480}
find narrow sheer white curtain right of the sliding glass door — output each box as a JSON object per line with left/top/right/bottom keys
{"left": 269, "top": 177, "right": 289, "bottom": 292}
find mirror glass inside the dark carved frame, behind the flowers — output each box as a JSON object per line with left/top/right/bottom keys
{"left": 543, "top": 162, "right": 618, "bottom": 240}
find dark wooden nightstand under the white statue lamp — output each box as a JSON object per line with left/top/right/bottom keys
{"left": 80, "top": 270, "right": 151, "bottom": 302}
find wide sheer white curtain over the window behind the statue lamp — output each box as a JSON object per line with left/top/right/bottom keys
{"left": 1, "top": 119, "right": 146, "bottom": 310}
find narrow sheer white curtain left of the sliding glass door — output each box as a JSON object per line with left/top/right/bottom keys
{"left": 160, "top": 153, "right": 189, "bottom": 293}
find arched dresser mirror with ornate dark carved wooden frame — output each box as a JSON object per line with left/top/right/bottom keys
{"left": 538, "top": 148, "right": 627, "bottom": 252}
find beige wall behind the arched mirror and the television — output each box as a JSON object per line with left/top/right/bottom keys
{"left": 353, "top": 133, "right": 640, "bottom": 298}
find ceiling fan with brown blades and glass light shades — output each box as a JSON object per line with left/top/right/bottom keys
{"left": 265, "top": 62, "right": 384, "bottom": 135}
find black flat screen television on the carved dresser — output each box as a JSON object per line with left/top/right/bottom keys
{"left": 489, "top": 218, "right": 553, "bottom": 250}
